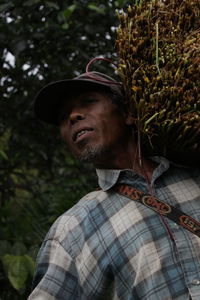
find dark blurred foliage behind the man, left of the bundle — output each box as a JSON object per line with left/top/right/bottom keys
{"left": 0, "top": 0, "right": 130, "bottom": 300}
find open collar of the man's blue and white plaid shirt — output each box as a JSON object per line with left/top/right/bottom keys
{"left": 96, "top": 156, "right": 170, "bottom": 191}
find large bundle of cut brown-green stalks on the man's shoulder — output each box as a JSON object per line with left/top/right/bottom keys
{"left": 116, "top": 0, "right": 200, "bottom": 162}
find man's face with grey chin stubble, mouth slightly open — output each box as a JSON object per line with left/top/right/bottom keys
{"left": 60, "top": 92, "right": 129, "bottom": 164}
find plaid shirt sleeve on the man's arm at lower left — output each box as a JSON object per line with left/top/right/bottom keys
{"left": 28, "top": 239, "right": 80, "bottom": 300}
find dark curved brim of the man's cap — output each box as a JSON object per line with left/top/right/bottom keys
{"left": 34, "top": 79, "right": 110, "bottom": 126}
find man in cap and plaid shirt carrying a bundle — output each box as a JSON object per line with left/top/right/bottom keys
{"left": 29, "top": 72, "right": 200, "bottom": 300}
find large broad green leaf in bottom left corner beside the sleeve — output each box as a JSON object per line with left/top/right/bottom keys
{"left": 2, "top": 254, "right": 29, "bottom": 291}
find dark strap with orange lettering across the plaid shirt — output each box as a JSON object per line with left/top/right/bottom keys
{"left": 114, "top": 184, "right": 200, "bottom": 237}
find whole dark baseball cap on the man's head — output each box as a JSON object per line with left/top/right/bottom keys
{"left": 34, "top": 71, "right": 123, "bottom": 126}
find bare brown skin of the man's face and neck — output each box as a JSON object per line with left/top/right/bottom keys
{"left": 60, "top": 92, "right": 155, "bottom": 181}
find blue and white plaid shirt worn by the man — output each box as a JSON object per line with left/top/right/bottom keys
{"left": 29, "top": 159, "right": 200, "bottom": 300}
